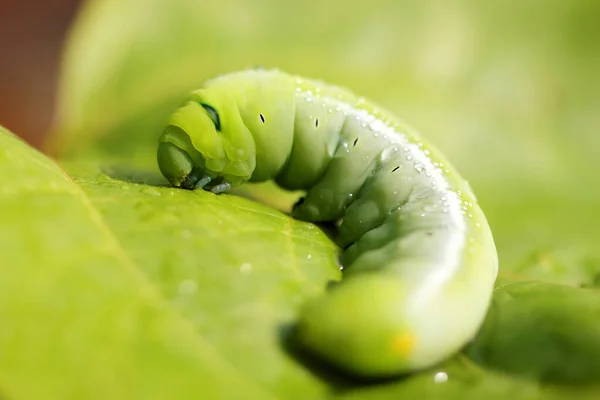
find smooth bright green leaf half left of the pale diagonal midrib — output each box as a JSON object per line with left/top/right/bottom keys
{"left": 0, "top": 129, "right": 271, "bottom": 399}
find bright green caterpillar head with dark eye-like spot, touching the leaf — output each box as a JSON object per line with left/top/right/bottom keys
{"left": 157, "top": 90, "right": 254, "bottom": 189}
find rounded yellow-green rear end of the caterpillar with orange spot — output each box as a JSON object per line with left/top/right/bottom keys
{"left": 296, "top": 273, "right": 488, "bottom": 379}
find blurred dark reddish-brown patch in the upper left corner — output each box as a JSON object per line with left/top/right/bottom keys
{"left": 0, "top": 0, "right": 81, "bottom": 147}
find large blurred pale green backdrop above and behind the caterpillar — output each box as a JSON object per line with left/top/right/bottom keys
{"left": 51, "top": 0, "right": 600, "bottom": 276}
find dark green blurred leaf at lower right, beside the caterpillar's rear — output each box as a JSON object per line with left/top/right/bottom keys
{"left": 467, "top": 282, "right": 600, "bottom": 385}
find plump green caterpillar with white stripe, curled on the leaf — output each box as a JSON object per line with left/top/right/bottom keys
{"left": 157, "top": 69, "right": 498, "bottom": 378}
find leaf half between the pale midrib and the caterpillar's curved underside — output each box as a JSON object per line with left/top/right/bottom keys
{"left": 65, "top": 158, "right": 340, "bottom": 398}
